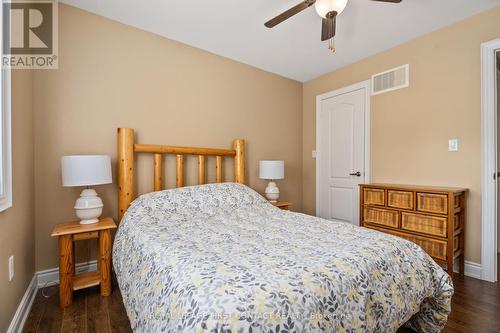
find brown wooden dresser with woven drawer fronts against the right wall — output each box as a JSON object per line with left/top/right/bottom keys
{"left": 359, "top": 184, "right": 468, "bottom": 276}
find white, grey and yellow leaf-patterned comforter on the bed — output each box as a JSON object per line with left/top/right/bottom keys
{"left": 113, "top": 183, "right": 453, "bottom": 333}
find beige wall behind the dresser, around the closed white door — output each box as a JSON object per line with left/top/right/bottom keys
{"left": 302, "top": 7, "right": 500, "bottom": 262}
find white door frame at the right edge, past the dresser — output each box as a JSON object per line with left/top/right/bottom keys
{"left": 481, "top": 38, "right": 500, "bottom": 282}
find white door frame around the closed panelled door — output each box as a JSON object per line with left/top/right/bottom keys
{"left": 316, "top": 80, "right": 371, "bottom": 218}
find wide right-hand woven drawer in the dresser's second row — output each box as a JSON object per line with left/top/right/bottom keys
{"left": 401, "top": 212, "right": 448, "bottom": 237}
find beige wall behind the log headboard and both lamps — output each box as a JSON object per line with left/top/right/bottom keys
{"left": 34, "top": 5, "right": 302, "bottom": 270}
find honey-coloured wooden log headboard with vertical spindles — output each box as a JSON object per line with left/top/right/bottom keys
{"left": 118, "top": 128, "right": 245, "bottom": 221}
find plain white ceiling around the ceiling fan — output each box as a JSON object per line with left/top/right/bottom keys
{"left": 60, "top": 0, "right": 500, "bottom": 82}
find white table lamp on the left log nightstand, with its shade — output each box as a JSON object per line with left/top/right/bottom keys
{"left": 61, "top": 155, "right": 112, "bottom": 224}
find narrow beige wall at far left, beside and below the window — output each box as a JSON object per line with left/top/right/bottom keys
{"left": 0, "top": 70, "right": 35, "bottom": 332}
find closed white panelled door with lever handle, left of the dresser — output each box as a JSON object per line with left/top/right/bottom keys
{"left": 316, "top": 86, "right": 369, "bottom": 225}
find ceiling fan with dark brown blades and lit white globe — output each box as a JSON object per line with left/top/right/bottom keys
{"left": 264, "top": 0, "right": 402, "bottom": 52}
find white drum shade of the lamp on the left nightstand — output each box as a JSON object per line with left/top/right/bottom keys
{"left": 61, "top": 155, "right": 113, "bottom": 187}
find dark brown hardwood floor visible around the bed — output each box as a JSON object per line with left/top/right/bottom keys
{"left": 24, "top": 256, "right": 500, "bottom": 333}
